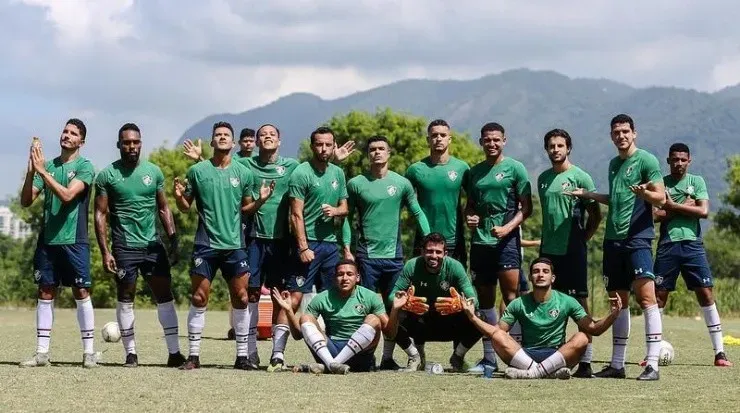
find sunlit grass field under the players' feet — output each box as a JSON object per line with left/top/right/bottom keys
{"left": 0, "top": 309, "right": 740, "bottom": 413}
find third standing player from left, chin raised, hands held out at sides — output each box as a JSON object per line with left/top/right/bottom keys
{"left": 174, "top": 122, "right": 256, "bottom": 370}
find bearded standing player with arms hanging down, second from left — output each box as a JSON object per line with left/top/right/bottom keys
{"left": 95, "top": 123, "right": 185, "bottom": 367}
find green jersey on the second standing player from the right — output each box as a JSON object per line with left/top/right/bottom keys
{"left": 604, "top": 149, "right": 663, "bottom": 240}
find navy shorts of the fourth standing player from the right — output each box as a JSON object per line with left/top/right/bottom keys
{"left": 470, "top": 235, "right": 522, "bottom": 285}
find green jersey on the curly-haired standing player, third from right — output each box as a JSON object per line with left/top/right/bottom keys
{"left": 537, "top": 165, "right": 596, "bottom": 255}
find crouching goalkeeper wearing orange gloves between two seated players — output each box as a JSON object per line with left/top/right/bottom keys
{"left": 387, "top": 233, "right": 481, "bottom": 371}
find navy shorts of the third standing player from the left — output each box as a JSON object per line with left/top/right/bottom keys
{"left": 190, "top": 245, "right": 249, "bottom": 281}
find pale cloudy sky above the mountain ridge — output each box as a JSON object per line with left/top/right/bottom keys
{"left": 0, "top": 0, "right": 740, "bottom": 198}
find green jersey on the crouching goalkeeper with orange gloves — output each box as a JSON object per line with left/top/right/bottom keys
{"left": 388, "top": 257, "right": 478, "bottom": 311}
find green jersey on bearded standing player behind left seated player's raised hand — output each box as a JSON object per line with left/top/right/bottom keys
{"left": 289, "top": 162, "right": 347, "bottom": 242}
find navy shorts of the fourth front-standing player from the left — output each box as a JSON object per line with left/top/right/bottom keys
{"left": 247, "top": 238, "right": 298, "bottom": 290}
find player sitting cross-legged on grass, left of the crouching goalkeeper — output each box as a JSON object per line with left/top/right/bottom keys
{"left": 272, "top": 260, "right": 388, "bottom": 374}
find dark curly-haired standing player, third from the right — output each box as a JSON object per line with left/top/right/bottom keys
{"left": 537, "top": 129, "right": 601, "bottom": 378}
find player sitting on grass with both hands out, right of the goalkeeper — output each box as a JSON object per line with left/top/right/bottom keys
{"left": 463, "top": 258, "right": 622, "bottom": 379}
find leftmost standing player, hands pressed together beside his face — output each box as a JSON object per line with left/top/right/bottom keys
{"left": 20, "top": 119, "right": 97, "bottom": 368}
